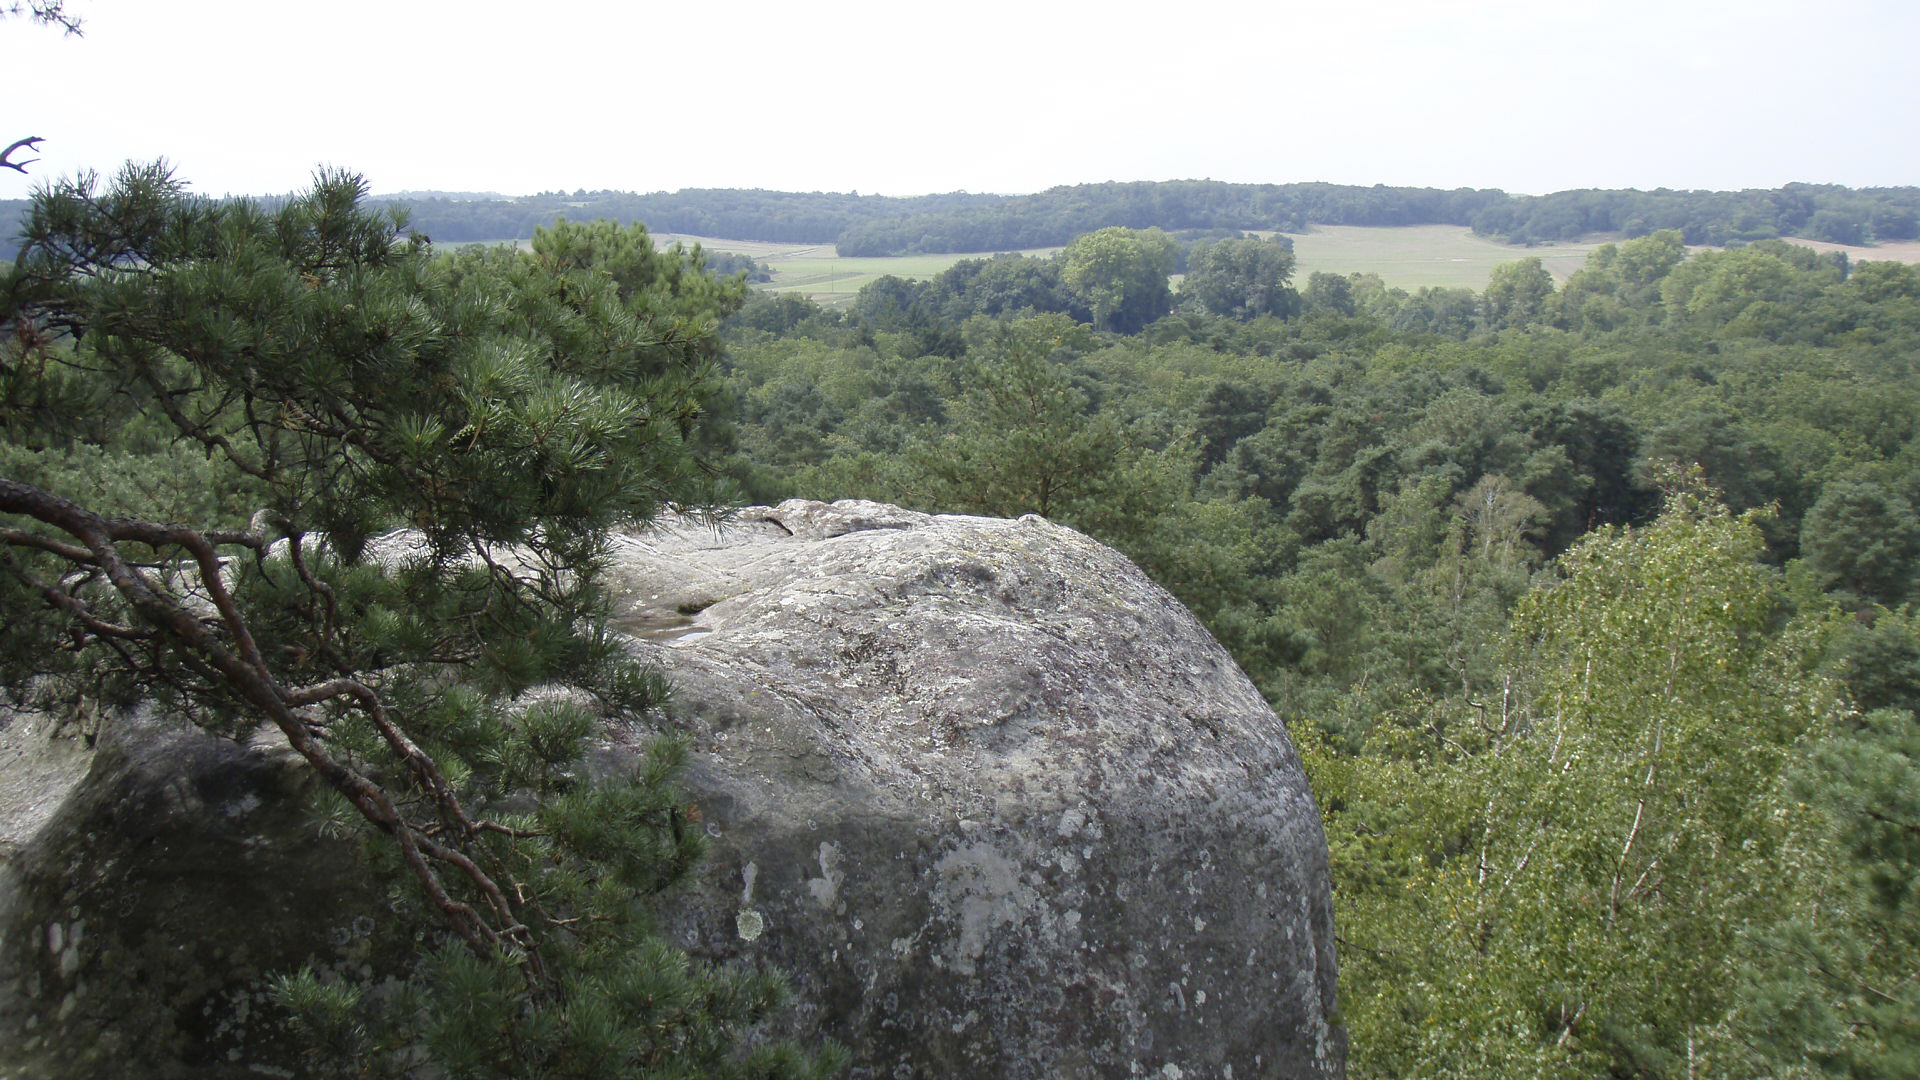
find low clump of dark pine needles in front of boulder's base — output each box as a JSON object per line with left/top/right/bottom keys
{"left": 275, "top": 726, "right": 845, "bottom": 1080}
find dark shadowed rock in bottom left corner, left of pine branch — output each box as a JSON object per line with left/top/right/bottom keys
{"left": 0, "top": 715, "right": 389, "bottom": 1080}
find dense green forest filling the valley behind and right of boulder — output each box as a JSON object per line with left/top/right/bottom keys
{"left": 726, "top": 229, "right": 1920, "bottom": 1078}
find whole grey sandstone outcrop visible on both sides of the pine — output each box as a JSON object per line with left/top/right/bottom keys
{"left": 0, "top": 502, "right": 1344, "bottom": 1080}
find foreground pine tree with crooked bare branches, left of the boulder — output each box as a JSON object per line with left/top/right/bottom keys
{"left": 0, "top": 165, "right": 833, "bottom": 1078}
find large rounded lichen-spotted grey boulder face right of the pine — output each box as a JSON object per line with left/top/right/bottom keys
{"left": 616, "top": 502, "right": 1344, "bottom": 1080}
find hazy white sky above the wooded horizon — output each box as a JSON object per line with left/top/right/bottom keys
{"left": 0, "top": 0, "right": 1920, "bottom": 198}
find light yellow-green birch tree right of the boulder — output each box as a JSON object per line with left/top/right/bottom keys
{"left": 1315, "top": 480, "right": 1843, "bottom": 1076}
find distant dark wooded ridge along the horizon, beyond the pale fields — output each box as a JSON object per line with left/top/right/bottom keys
{"left": 0, "top": 181, "right": 1920, "bottom": 256}
